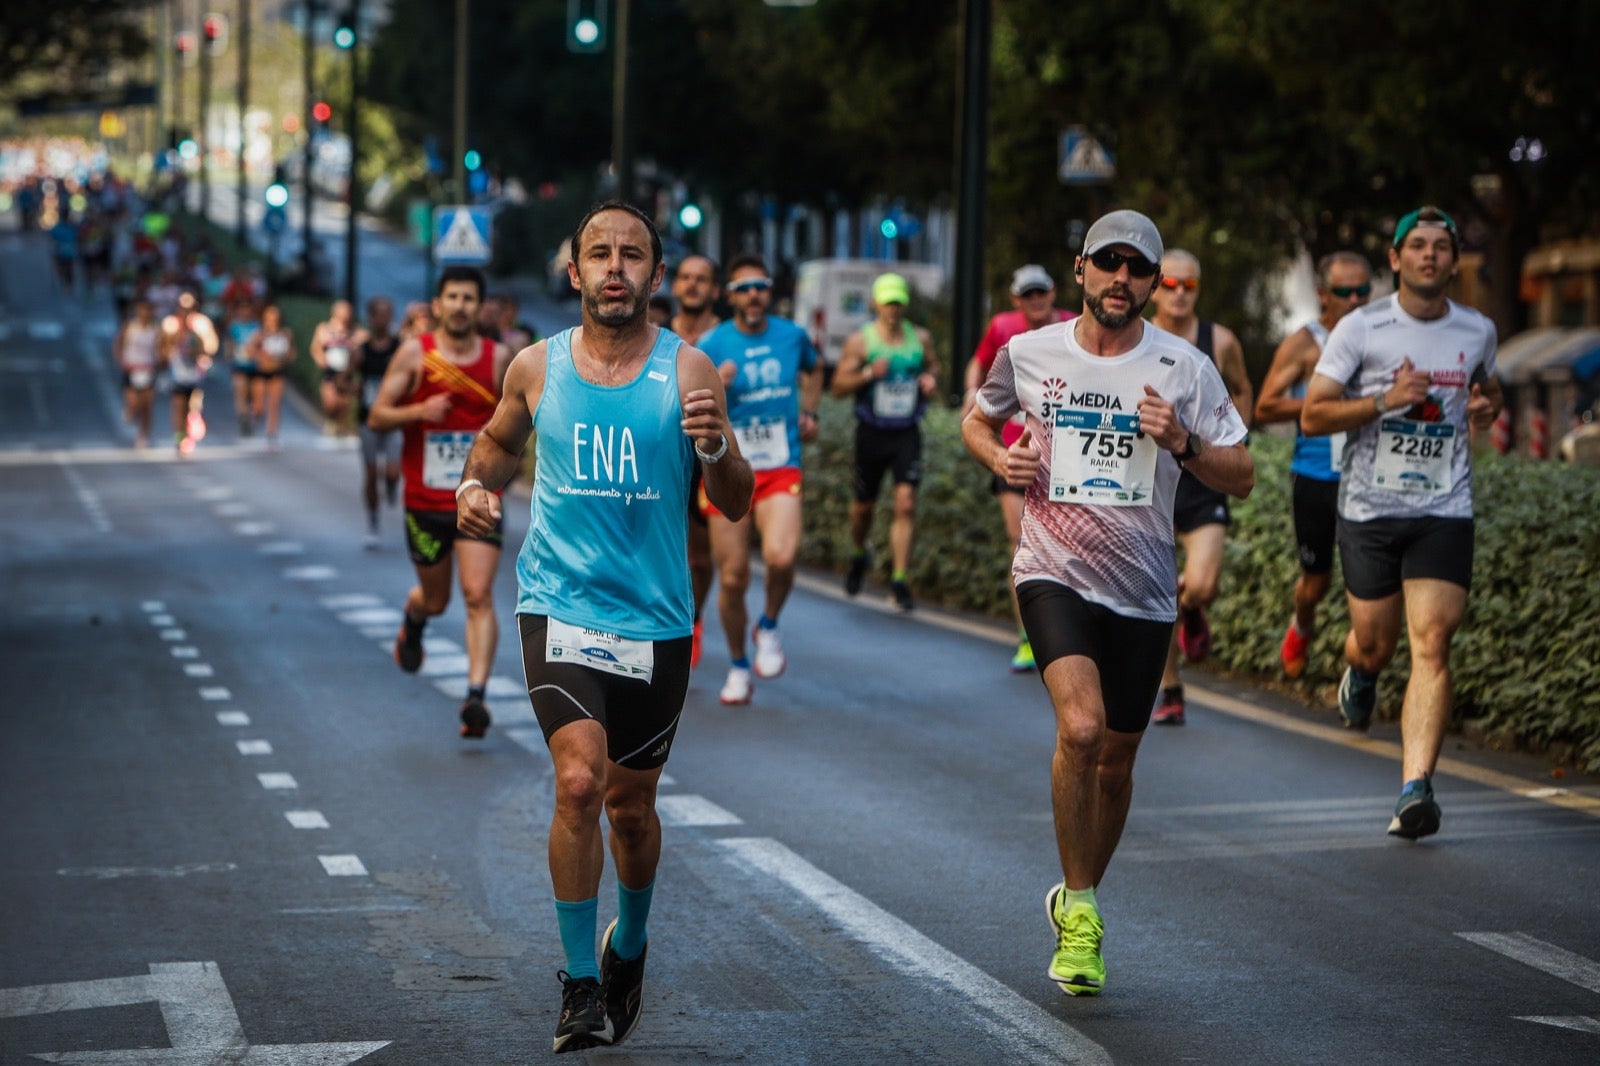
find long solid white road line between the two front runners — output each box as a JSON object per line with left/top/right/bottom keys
{"left": 715, "top": 837, "right": 1112, "bottom": 1066}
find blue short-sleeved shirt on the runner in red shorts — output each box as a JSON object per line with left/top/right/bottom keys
{"left": 696, "top": 317, "right": 816, "bottom": 471}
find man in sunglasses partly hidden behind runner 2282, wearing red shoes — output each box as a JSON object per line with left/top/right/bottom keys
{"left": 1256, "top": 251, "right": 1373, "bottom": 677}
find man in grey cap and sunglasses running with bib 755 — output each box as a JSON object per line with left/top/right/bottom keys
{"left": 962, "top": 211, "right": 1254, "bottom": 996}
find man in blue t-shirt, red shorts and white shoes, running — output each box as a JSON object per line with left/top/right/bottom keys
{"left": 699, "top": 254, "right": 822, "bottom": 704}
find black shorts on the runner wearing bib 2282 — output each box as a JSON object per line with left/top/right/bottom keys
{"left": 1339, "top": 517, "right": 1474, "bottom": 600}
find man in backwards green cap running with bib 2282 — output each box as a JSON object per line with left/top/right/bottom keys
{"left": 1301, "top": 206, "right": 1502, "bottom": 840}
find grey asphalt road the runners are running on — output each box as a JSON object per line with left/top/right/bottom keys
{"left": 9, "top": 219, "right": 1600, "bottom": 1066}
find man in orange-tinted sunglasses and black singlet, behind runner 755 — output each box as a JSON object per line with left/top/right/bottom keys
{"left": 1152, "top": 248, "right": 1253, "bottom": 725}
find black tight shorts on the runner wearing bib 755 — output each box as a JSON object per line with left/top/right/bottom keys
{"left": 1016, "top": 579, "right": 1173, "bottom": 733}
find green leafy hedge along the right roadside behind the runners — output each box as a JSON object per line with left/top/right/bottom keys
{"left": 802, "top": 400, "right": 1600, "bottom": 770}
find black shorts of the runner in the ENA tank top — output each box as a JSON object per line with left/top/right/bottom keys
{"left": 517, "top": 615, "right": 693, "bottom": 770}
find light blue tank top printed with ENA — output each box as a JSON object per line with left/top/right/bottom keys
{"left": 517, "top": 330, "right": 694, "bottom": 640}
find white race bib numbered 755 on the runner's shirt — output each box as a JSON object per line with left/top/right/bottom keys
{"left": 1050, "top": 410, "right": 1155, "bottom": 507}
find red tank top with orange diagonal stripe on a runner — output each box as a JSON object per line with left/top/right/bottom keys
{"left": 400, "top": 333, "right": 499, "bottom": 511}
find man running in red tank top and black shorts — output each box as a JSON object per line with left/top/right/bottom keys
{"left": 366, "top": 260, "right": 510, "bottom": 738}
